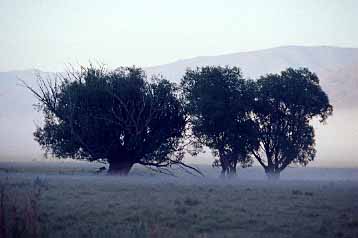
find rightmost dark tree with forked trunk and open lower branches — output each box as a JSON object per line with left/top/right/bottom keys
{"left": 251, "top": 68, "right": 333, "bottom": 178}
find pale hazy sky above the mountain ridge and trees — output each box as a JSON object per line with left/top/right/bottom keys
{"left": 0, "top": 0, "right": 358, "bottom": 71}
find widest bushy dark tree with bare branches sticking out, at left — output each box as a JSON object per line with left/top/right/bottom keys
{"left": 26, "top": 66, "right": 199, "bottom": 175}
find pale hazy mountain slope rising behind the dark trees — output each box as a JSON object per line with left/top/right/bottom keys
{"left": 0, "top": 46, "right": 358, "bottom": 167}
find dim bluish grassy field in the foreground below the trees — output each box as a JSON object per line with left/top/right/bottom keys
{"left": 0, "top": 163, "right": 358, "bottom": 238}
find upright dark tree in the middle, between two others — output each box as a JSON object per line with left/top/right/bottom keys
{"left": 181, "top": 66, "right": 257, "bottom": 176}
